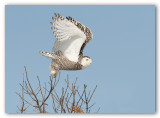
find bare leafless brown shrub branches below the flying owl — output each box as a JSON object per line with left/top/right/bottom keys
{"left": 16, "top": 67, "right": 99, "bottom": 113}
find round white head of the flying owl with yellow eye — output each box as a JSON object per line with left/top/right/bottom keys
{"left": 81, "top": 56, "right": 92, "bottom": 69}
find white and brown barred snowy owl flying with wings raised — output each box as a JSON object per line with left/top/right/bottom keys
{"left": 39, "top": 14, "right": 93, "bottom": 77}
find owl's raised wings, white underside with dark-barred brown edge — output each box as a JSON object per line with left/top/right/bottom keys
{"left": 51, "top": 14, "right": 92, "bottom": 62}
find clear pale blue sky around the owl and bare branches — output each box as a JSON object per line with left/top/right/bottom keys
{"left": 5, "top": 5, "right": 155, "bottom": 113}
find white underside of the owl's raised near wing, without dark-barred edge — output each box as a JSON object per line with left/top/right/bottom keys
{"left": 51, "top": 15, "right": 86, "bottom": 62}
